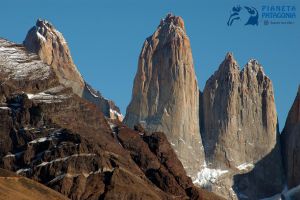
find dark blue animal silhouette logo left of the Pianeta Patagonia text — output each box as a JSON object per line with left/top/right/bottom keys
{"left": 227, "top": 5, "right": 259, "bottom": 26}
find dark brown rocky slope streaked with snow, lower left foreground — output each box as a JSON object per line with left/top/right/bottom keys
{"left": 0, "top": 35, "right": 222, "bottom": 200}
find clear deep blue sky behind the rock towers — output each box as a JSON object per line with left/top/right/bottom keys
{"left": 0, "top": 0, "right": 300, "bottom": 129}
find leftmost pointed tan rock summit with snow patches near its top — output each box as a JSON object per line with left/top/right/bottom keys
{"left": 23, "top": 19, "right": 84, "bottom": 96}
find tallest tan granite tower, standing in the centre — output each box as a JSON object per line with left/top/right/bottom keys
{"left": 124, "top": 14, "right": 203, "bottom": 178}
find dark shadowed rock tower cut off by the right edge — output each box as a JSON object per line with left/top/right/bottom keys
{"left": 281, "top": 86, "right": 300, "bottom": 188}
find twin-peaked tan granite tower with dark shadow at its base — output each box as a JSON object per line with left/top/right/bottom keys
{"left": 201, "top": 53, "right": 283, "bottom": 199}
